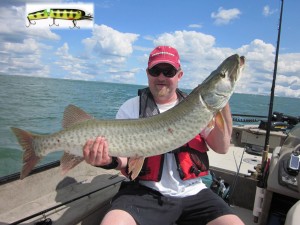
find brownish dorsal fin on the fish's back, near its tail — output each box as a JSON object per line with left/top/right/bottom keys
{"left": 62, "top": 105, "right": 93, "bottom": 128}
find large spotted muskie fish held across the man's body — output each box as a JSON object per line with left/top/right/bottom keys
{"left": 11, "top": 54, "right": 245, "bottom": 179}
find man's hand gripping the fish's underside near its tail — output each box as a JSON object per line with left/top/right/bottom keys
{"left": 83, "top": 136, "right": 112, "bottom": 166}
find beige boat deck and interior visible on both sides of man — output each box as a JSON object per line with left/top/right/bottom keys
{"left": 0, "top": 127, "right": 288, "bottom": 225}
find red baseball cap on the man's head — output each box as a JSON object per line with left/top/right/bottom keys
{"left": 148, "top": 46, "right": 180, "bottom": 70}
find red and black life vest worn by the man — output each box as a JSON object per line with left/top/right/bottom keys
{"left": 123, "top": 88, "right": 209, "bottom": 181}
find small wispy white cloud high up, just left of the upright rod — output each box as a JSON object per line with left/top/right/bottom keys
{"left": 211, "top": 7, "right": 242, "bottom": 25}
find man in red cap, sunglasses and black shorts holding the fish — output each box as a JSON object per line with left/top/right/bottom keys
{"left": 83, "top": 46, "right": 244, "bottom": 225}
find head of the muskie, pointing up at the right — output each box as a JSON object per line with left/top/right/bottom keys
{"left": 200, "top": 54, "right": 245, "bottom": 111}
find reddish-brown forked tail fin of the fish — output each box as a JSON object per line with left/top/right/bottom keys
{"left": 11, "top": 127, "right": 41, "bottom": 180}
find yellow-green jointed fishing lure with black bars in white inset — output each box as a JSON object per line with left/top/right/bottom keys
{"left": 26, "top": 9, "right": 93, "bottom": 29}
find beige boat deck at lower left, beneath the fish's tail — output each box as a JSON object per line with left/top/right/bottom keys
{"left": 0, "top": 163, "right": 124, "bottom": 225}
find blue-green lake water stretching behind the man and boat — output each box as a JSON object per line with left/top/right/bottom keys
{"left": 0, "top": 75, "right": 300, "bottom": 177}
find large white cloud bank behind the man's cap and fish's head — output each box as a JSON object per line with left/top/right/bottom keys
{"left": 149, "top": 31, "right": 300, "bottom": 97}
